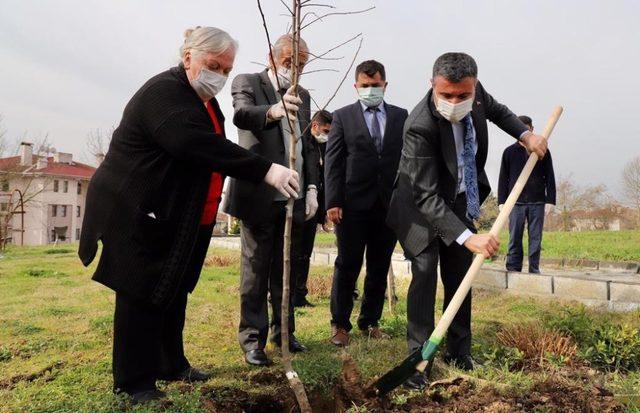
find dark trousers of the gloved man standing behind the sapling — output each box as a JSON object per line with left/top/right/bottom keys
{"left": 238, "top": 199, "right": 304, "bottom": 352}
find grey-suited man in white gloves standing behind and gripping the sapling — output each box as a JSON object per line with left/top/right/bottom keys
{"left": 225, "top": 35, "right": 318, "bottom": 366}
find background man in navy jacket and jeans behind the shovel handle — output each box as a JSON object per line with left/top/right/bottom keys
{"left": 498, "top": 116, "right": 556, "bottom": 274}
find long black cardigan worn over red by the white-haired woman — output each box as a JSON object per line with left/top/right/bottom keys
{"left": 79, "top": 66, "right": 271, "bottom": 307}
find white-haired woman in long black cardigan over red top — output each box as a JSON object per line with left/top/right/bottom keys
{"left": 79, "top": 27, "right": 299, "bottom": 402}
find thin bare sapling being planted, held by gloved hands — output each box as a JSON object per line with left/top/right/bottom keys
{"left": 256, "top": 0, "right": 373, "bottom": 413}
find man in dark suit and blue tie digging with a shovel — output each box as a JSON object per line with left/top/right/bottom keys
{"left": 387, "top": 53, "right": 546, "bottom": 389}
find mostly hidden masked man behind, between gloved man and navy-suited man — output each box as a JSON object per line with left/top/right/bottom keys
{"left": 293, "top": 110, "right": 333, "bottom": 307}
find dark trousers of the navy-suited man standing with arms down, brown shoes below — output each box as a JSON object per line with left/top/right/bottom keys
{"left": 331, "top": 200, "right": 397, "bottom": 331}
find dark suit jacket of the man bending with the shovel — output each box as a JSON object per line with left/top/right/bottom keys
{"left": 387, "top": 82, "right": 527, "bottom": 257}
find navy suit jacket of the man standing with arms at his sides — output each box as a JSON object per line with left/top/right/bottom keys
{"left": 325, "top": 101, "right": 407, "bottom": 211}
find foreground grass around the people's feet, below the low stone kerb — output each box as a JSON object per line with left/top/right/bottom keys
{"left": 0, "top": 243, "right": 640, "bottom": 412}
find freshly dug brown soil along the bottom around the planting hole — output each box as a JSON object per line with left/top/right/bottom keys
{"left": 202, "top": 357, "right": 624, "bottom": 413}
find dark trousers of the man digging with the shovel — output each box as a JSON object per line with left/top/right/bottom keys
{"left": 407, "top": 196, "right": 475, "bottom": 356}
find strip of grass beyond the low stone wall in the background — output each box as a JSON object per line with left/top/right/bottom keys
{"left": 316, "top": 230, "right": 640, "bottom": 262}
